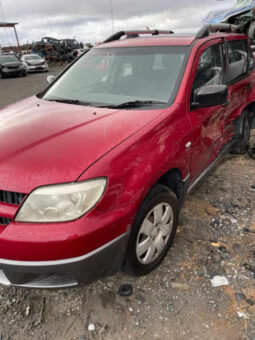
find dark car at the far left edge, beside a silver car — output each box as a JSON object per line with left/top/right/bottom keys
{"left": 0, "top": 55, "right": 27, "bottom": 78}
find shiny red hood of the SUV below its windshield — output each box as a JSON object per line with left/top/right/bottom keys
{"left": 0, "top": 97, "right": 163, "bottom": 193}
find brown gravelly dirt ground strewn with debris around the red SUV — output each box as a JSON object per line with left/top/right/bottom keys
{"left": 0, "top": 68, "right": 255, "bottom": 340}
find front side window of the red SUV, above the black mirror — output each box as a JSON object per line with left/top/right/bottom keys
{"left": 191, "top": 44, "right": 223, "bottom": 103}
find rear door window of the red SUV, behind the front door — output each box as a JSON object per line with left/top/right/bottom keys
{"left": 227, "top": 40, "right": 248, "bottom": 82}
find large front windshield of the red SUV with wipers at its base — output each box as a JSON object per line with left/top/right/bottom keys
{"left": 43, "top": 46, "right": 188, "bottom": 106}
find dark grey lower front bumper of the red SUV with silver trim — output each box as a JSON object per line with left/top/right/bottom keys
{"left": 0, "top": 232, "right": 129, "bottom": 288}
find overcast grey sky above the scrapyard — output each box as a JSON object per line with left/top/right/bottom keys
{"left": 0, "top": 0, "right": 235, "bottom": 45}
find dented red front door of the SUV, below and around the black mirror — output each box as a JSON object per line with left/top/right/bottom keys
{"left": 188, "top": 39, "right": 225, "bottom": 181}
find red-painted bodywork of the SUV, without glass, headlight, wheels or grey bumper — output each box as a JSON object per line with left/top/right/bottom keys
{"left": 0, "top": 34, "right": 255, "bottom": 261}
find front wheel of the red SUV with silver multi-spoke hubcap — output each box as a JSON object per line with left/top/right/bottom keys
{"left": 123, "top": 185, "right": 179, "bottom": 276}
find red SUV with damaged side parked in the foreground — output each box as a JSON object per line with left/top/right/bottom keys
{"left": 0, "top": 25, "right": 255, "bottom": 288}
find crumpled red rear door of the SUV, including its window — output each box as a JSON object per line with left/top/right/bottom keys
{"left": 223, "top": 38, "right": 251, "bottom": 143}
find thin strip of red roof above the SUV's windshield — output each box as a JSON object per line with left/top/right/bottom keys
{"left": 96, "top": 32, "right": 247, "bottom": 48}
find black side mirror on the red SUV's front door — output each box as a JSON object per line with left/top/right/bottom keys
{"left": 191, "top": 85, "right": 228, "bottom": 109}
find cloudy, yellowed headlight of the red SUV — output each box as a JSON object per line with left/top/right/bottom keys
{"left": 15, "top": 178, "right": 107, "bottom": 223}
